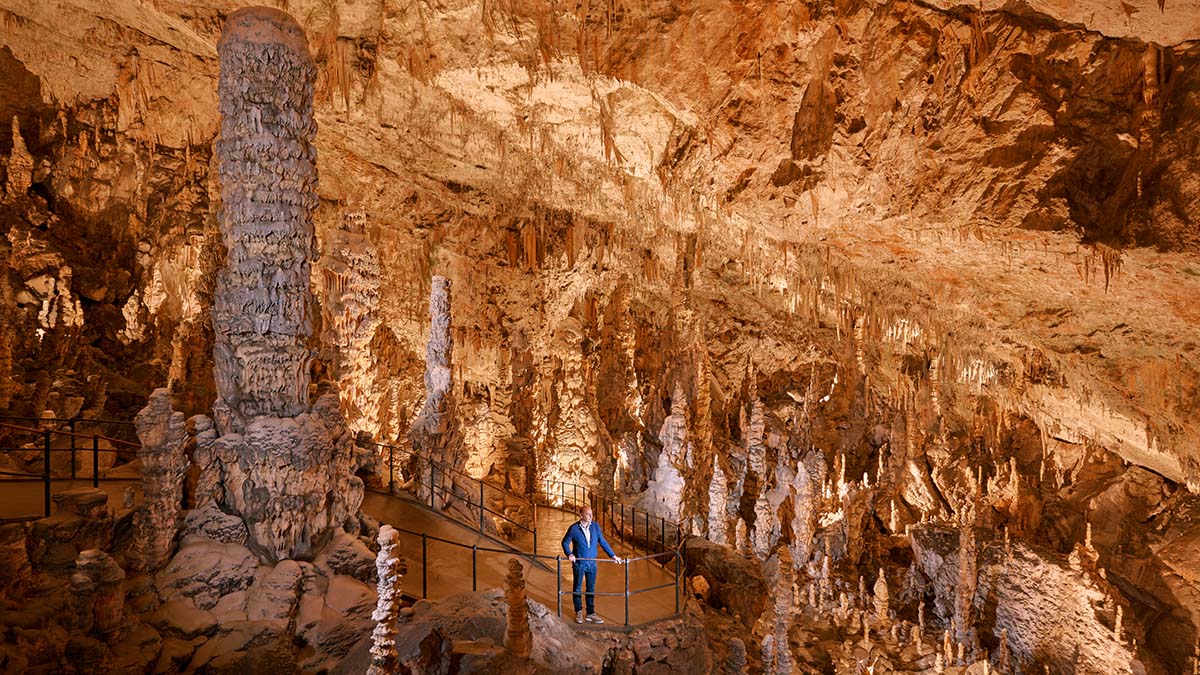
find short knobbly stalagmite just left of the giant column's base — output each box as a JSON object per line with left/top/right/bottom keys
{"left": 130, "top": 389, "right": 187, "bottom": 572}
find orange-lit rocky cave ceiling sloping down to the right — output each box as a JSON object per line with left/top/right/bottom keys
{"left": 0, "top": 0, "right": 1200, "bottom": 489}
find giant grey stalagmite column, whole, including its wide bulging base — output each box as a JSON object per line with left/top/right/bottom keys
{"left": 211, "top": 7, "right": 364, "bottom": 562}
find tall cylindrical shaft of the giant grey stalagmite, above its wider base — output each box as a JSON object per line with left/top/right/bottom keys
{"left": 212, "top": 7, "right": 317, "bottom": 418}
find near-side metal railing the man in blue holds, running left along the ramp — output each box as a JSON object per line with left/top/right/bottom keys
{"left": 384, "top": 526, "right": 684, "bottom": 627}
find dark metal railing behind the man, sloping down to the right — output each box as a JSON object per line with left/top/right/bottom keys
{"left": 538, "top": 479, "right": 683, "bottom": 562}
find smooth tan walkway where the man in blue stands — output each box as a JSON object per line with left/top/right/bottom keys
{"left": 362, "top": 492, "right": 676, "bottom": 626}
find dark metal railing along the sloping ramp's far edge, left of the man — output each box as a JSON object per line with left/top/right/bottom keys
{"left": 366, "top": 441, "right": 538, "bottom": 552}
